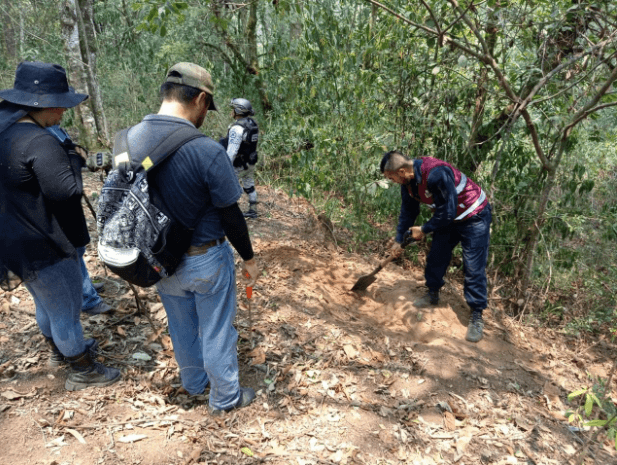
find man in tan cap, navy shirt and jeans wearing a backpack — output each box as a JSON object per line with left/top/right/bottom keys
{"left": 114, "top": 63, "right": 259, "bottom": 414}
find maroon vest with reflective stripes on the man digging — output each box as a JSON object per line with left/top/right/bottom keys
{"left": 407, "top": 157, "right": 488, "bottom": 221}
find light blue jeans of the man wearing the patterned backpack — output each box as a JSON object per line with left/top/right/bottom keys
{"left": 156, "top": 242, "right": 240, "bottom": 409}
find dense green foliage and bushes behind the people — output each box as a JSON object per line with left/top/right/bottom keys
{"left": 0, "top": 0, "right": 617, "bottom": 332}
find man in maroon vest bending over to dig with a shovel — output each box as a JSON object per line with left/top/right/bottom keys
{"left": 380, "top": 151, "right": 492, "bottom": 342}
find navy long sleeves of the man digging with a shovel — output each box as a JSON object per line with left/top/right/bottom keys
{"left": 395, "top": 160, "right": 458, "bottom": 243}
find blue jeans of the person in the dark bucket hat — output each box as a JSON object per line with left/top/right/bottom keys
{"left": 24, "top": 256, "right": 86, "bottom": 357}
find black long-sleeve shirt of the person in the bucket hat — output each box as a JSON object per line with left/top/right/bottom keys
{"left": 0, "top": 123, "right": 90, "bottom": 280}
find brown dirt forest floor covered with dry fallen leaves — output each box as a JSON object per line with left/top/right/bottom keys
{"left": 0, "top": 175, "right": 617, "bottom": 465}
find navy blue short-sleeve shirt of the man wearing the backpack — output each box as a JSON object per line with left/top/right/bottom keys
{"left": 128, "top": 115, "right": 242, "bottom": 245}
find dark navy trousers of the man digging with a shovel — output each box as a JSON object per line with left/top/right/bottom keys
{"left": 424, "top": 204, "right": 492, "bottom": 311}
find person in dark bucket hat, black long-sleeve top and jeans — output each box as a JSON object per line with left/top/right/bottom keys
{"left": 0, "top": 62, "right": 120, "bottom": 391}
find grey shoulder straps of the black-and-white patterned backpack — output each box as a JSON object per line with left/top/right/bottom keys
{"left": 113, "top": 126, "right": 206, "bottom": 172}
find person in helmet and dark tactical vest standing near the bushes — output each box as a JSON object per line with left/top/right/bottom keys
{"left": 220, "top": 98, "right": 259, "bottom": 218}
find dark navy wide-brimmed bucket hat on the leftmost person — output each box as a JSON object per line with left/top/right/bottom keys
{"left": 0, "top": 61, "right": 88, "bottom": 108}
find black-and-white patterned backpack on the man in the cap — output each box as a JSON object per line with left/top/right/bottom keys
{"left": 96, "top": 127, "right": 205, "bottom": 287}
